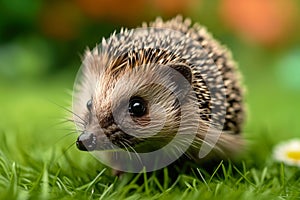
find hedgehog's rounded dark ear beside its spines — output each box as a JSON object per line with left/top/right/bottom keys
{"left": 167, "top": 63, "right": 192, "bottom": 98}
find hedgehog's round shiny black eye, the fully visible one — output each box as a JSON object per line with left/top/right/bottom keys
{"left": 128, "top": 97, "right": 147, "bottom": 117}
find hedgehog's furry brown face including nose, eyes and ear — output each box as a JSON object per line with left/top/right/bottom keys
{"left": 75, "top": 60, "right": 191, "bottom": 151}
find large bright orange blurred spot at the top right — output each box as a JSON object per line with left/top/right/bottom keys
{"left": 220, "top": 0, "right": 297, "bottom": 45}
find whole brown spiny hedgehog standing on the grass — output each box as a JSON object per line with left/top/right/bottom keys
{"left": 73, "top": 16, "right": 245, "bottom": 172}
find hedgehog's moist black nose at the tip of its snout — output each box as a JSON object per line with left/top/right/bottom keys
{"left": 76, "top": 131, "right": 97, "bottom": 151}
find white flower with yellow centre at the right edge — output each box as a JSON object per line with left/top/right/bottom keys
{"left": 273, "top": 139, "right": 300, "bottom": 167}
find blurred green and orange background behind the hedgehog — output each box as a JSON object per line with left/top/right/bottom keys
{"left": 0, "top": 0, "right": 300, "bottom": 175}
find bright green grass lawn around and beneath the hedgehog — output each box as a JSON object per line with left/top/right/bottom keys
{"left": 0, "top": 60, "right": 300, "bottom": 199}
